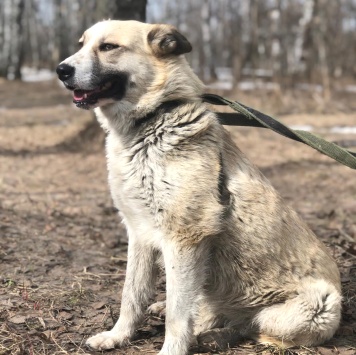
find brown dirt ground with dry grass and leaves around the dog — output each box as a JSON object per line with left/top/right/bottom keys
{"left": 0, "top": 81, "right": 356, "bottom": 355}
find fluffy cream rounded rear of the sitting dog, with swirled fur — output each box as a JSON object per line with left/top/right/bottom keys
{"left": 253, "top": 280, "right": 341, "bottom": 347}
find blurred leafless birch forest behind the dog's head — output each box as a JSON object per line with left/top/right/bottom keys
{"left": 0, "top": 0, "right": 356, "bottom": 99}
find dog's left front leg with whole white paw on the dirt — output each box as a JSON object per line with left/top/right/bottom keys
{"left": 86, "top": 237, "right": 156, "bottom": 350}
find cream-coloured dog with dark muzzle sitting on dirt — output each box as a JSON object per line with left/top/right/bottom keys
{"left": 57, "top": 20, "right": 342, "bottom": 355}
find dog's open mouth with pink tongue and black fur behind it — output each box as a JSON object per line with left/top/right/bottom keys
{"left": 67, "top": 74, "right": 127, "bottom": 110}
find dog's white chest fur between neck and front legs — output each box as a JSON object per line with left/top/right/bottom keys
{"left": 107, "top": 131, "right": 171, "bottom": 239}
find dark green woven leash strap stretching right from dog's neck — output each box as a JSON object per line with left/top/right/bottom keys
{"left": 203, "top": 94, "right": 356, "bottom": 169}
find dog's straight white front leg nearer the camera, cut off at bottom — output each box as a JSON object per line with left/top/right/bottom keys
{"left": 158, "top": 242, "right": 206, "bottom": 355}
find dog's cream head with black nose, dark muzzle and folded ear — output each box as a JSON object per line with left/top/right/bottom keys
{"left": 57, "top": 20, "right": 199, "bottom": 109}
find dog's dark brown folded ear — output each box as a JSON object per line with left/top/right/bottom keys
{"left": 147, "top": 25, "right": 192, "bottom": 57}
